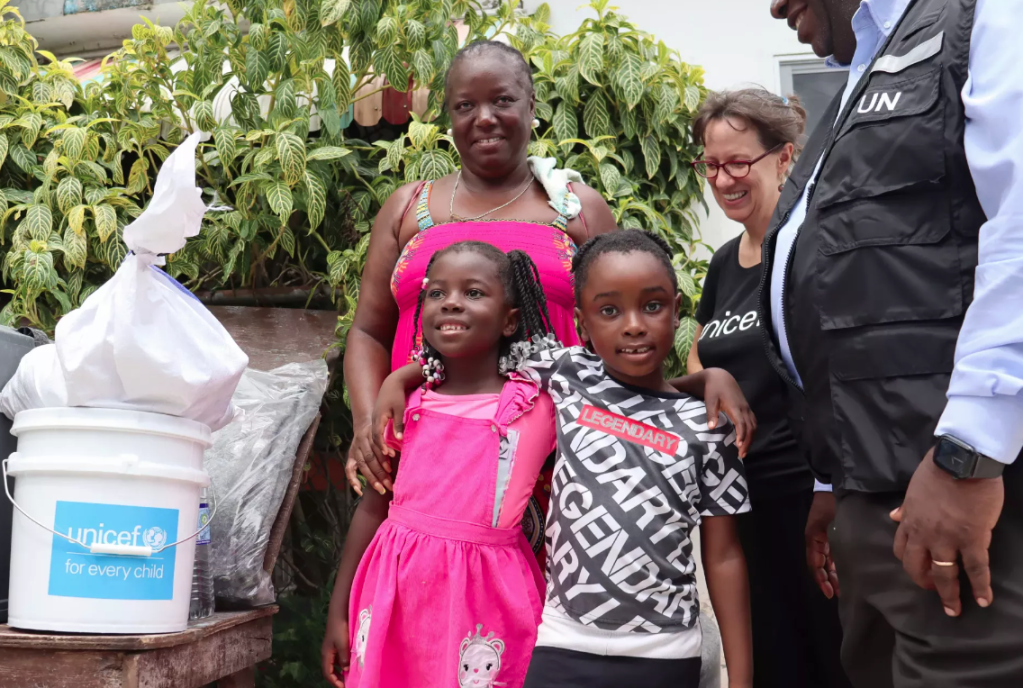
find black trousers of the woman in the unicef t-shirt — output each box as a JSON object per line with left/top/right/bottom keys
{"left": 738, "top": 490, "right": 849, "bottom": 688}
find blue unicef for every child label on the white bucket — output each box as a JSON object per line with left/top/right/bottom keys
{"left": 49, "top": 502, "right": 178, "bottom": 600}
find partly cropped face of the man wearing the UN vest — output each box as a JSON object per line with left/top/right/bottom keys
{"left": 770, "top": 0, "right": 859, "bottom": 64}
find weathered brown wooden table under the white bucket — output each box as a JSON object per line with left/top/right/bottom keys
{"left": 0, "top": 606, "right": 277, "bottom": 688}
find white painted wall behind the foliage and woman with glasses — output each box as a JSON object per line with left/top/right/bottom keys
{"left": 525, "top": 0, "right": 812, "bottom": 248}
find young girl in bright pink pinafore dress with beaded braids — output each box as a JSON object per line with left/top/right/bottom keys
{"left": 323, "top": 241, "right": 555, "bottom": 688}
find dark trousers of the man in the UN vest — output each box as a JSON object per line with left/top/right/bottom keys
{"left": 831, "top": 461, "right": 1023, "bottom": 688}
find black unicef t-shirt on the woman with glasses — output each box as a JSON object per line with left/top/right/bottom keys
{"left": 697, "top": 236, "right": 813, "bottom": 502}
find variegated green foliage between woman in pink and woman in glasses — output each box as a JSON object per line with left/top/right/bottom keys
{"left": 519, "top": 0, "right": 707, "bottom": 374}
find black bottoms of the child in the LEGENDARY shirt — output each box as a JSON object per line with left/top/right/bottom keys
{"left": 524, "top": 647, "right": 700, "bottom": 688}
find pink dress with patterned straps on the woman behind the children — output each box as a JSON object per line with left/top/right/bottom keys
{"left": 391, "top": 181, "right": 585, "bottom": 556}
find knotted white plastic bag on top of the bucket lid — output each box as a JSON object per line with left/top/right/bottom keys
{"left": 56, "top": 133, "right": 249, "bottom": 430}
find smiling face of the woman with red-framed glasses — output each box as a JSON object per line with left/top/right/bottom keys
{"left": 703, "top": 118, "right": 792, "bottom": 224}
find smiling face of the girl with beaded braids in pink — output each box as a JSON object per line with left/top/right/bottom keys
{"left": 422, "top": 250, "right": 519, "bottom": 359}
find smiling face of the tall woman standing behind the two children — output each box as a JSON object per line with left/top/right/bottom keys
{"left": 445, "top": 50, "right": 536, "bottom": 179}
